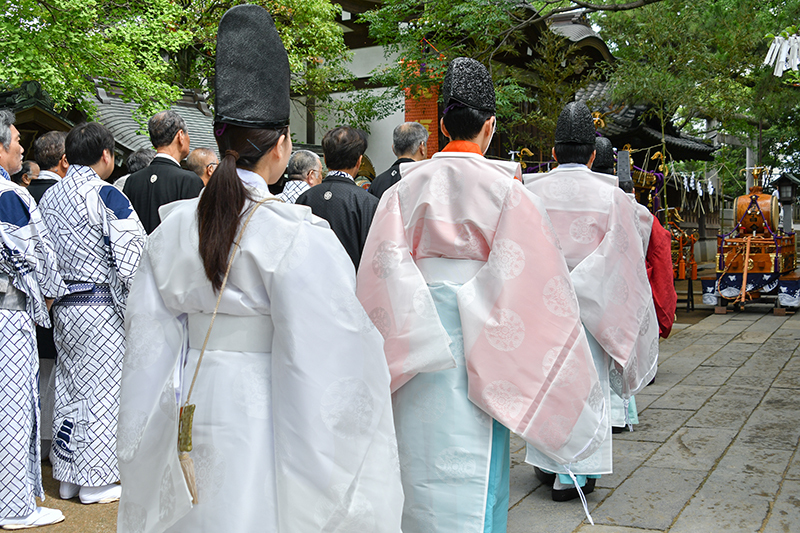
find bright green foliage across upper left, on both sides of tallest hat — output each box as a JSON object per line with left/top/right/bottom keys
{"left": 0, "top": 0, "right": 386, "bottom": 126}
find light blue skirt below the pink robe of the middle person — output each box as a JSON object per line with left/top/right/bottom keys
{"left": 393, "top": 280, "right": 510, "bottom": 533}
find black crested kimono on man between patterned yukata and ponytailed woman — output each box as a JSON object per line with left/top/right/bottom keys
{"left": 122, "top": 156, "right": 203, "bottom": 235}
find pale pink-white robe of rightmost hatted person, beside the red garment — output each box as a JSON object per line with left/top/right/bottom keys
{"left": 525, "top": 165, "right": 658, "bottom": 474}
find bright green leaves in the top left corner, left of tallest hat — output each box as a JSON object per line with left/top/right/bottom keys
{"left": 0, "top": 0, "right": 189, "bottom": 118}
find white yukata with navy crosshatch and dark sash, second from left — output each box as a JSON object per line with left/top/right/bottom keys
{"left": 41, "top": 165, "right": 146, "bottom": 487}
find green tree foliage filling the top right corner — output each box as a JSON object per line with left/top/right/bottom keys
{"left": 595, "top": 0, "right": 800, "bottom": 194}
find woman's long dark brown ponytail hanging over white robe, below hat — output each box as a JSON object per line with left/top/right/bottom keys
{"left": 197, "top": 122, "right": 289, "bottom": 291}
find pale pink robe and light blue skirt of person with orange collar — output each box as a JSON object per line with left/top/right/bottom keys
{"left": 358, "top": 152, "right": 608, "bottom": 533}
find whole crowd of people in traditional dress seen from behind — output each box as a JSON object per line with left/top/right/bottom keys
{"left": 0, "top": 5, "right": 676, "bottom": 533}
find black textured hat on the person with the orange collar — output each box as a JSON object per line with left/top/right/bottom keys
{"left": 442, "top": 57, "right": 496, "bottom": 113}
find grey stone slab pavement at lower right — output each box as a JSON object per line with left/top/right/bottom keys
{"left": 508, "top": 311, "right": 800, "bottom": 533}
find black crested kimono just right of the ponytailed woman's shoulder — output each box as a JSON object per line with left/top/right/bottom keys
{"left": 295, "top": 171, "right": 378, "bottom": 270}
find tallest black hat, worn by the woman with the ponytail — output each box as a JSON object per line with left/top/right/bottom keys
{"left": 214, "top": 4, "right": 290, "bottom": 129}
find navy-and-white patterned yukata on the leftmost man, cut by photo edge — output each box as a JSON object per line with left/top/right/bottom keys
{"left": 0, "top": 167, "right": 66, "bottom": 518}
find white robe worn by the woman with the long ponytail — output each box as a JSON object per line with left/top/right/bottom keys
{"left": 117, "top": 170, "right": 403, "bottom": 533}
